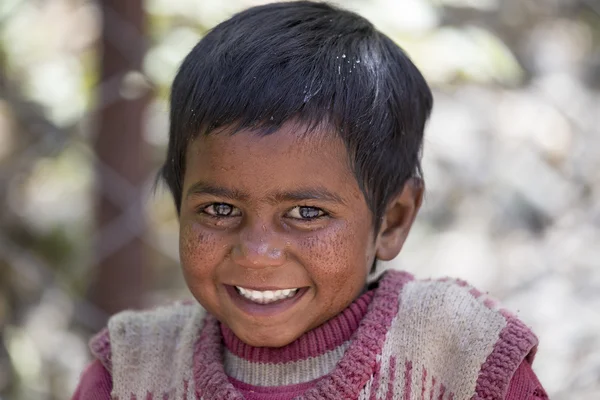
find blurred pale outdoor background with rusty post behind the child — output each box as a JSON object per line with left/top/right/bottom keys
{"left": 0, "top": 0, "right": 600, "bottom": 400}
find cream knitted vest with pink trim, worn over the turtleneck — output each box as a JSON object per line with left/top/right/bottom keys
{"left": 92, "top": 272, "right": 537, "bottom": 400}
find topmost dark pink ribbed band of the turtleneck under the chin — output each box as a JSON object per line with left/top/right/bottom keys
{"left": 220, "top": 290, "right": 374, "bottom": 363}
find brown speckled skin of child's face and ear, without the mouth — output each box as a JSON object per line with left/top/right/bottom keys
{"left": 180, "top": 122, "right": 423, "bottom": 347}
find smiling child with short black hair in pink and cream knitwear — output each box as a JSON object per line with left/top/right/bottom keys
{"left": 74, "top": 1, "right": 546, "bottom": 400}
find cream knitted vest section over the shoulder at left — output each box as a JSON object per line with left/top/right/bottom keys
{"left": 85, "top": 302, "right": 206, "bottom": 398}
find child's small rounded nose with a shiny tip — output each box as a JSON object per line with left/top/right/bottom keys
{"left": 231, "top": 224, "right": 286, "bottom": 268}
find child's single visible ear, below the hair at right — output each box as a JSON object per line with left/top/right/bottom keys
{"left": 376, "top": 178, "right": 424, "bottom": 261}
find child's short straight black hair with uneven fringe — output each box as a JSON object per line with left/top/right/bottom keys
{"left": 161, "top": 1, "right": 433, "bottom": 229}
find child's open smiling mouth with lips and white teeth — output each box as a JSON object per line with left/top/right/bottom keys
{"left": 225, "top": 285, "right": 308, "bottom": 316}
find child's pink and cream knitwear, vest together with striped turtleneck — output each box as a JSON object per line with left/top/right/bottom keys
{"left": 75, "top": 271, "right": 545, "bottom": 400}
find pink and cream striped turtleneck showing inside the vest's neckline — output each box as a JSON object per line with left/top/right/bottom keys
{"left": 219, "top": 290, "right": 375, "bottom": 400}
